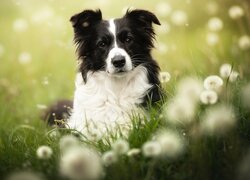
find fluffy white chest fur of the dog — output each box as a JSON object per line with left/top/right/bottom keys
{"left": 68, "top": 66, "right": 152, "bottom": 138}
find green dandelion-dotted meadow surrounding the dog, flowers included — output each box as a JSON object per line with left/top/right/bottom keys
{"left": 0, "top": 0, "right": 250, "bottom": 180}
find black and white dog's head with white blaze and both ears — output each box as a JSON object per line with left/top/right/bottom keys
{"left": 70, "top": 10, "right": 160, "bottom": 80}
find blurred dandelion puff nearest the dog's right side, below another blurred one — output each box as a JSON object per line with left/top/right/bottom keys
{"left": 164, "top": 97, "right": 196, "bottom": 124}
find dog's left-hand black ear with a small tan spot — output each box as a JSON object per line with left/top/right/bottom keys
{"left": 70, "top": 9, "right": 102, "bottom": 28}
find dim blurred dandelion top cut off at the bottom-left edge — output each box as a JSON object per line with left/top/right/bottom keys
{"left": 6, "top": 171, "right": 43, "bottom": 180}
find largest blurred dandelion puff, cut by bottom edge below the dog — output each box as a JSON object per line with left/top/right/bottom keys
{"left": 60, "top": 147, "right": 102, "bottom": 179}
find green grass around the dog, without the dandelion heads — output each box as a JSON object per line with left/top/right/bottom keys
{"left": 0, "top": 0, "right": 250, "bottom": 180}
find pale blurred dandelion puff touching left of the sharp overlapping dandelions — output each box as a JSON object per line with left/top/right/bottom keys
{"left": 177, "top": 77, "right": 203, "bottom": 102}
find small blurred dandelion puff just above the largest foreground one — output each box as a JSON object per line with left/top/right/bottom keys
{"left": 59, "top": 135, "right": 79, "bottom": 150}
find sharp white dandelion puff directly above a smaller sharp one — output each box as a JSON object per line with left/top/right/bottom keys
{"left": 204, "top": 75, "right": 223, "bottom": 91}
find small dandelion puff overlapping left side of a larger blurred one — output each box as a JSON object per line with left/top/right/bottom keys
{"left": 142, "top": 141, "right": 161, "bottom": 157}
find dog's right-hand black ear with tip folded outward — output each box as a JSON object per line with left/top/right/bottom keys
{"left": 125, "top": 9, "right": 161, "bottom": 26}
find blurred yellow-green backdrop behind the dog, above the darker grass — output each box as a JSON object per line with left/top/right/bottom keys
{"left": 0, "top": 0, "right": 250, "bottom": 128}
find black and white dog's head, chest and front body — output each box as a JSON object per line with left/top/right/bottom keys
{"left": 65, "top": 10, "right": 160, "bottom": 134}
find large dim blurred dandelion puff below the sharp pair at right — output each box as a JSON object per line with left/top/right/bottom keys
{"left": 201, "top": 105, "right": 236, "bottom": 135}
